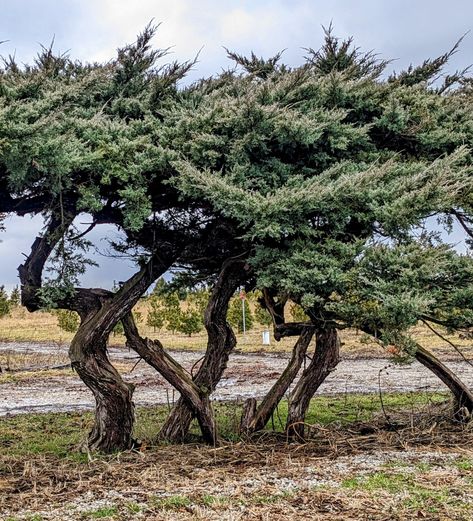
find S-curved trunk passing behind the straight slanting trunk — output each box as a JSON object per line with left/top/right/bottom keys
{"left": 160, "top": 259, "right": 248, "bottom": 442}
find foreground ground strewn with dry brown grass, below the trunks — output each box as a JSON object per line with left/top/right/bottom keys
{"left": 0, "top": 404, "right": 473, "bottom": 521}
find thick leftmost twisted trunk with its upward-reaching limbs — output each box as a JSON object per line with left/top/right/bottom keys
{"left": 19, "top": 214, "right": 176, "bottom": 452}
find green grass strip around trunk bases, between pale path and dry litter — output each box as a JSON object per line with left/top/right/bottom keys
{"left": 0, "top": 393, "right": 450, "bottom": 460}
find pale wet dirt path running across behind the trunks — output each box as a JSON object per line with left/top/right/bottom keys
{"left": 0, "top": 343, "right": 473, "bottom": 416}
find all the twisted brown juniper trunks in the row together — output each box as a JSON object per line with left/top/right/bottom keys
{"left": 13, "top": 216, "right": 473, "bottom": 452}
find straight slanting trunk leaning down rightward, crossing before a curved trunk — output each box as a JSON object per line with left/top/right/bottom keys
{"left": 123, "top": 314, "right": 218, "bottom": 445}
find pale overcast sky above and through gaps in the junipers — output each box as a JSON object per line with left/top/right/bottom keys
{"left": 0, "top": 0, "right": 473, "bottom": 289}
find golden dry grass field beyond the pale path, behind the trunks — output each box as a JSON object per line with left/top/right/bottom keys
{"left": 0, "top": 301, "right": 473, "bottom": 359}
